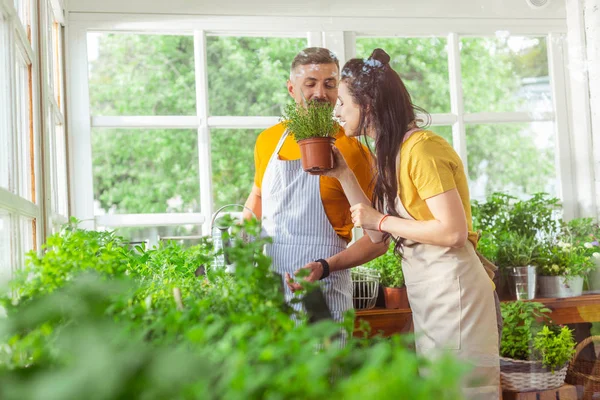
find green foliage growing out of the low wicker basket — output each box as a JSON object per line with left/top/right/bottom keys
{"left": 500, "top": 301, "right": 576, "bottom": 371}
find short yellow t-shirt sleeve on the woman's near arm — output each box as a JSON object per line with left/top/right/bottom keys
{"left": 408, "top": 139, "right": 460, "bottom": 200}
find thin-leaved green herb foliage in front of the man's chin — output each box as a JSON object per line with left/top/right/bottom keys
{"left": 282, "top": 101, "right": 339, "bottom": 142}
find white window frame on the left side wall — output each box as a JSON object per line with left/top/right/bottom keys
{"left": 0, "top": 0, "right": 44, "bottom": 273}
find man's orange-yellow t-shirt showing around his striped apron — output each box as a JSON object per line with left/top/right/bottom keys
{"left": 254, "top": 123, "right": 374, "bottom": 242}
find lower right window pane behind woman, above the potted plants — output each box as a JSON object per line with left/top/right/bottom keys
{"left": 466, "top": 122, "right": 558, "bottom": 201}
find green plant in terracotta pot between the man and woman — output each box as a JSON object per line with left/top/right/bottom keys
{"left": 366, "top": 241, "right": 410, "bottom": 308}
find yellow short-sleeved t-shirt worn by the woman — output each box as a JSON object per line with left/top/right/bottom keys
{"left": 398, "top": 130, "right": 477, "bottom": 247}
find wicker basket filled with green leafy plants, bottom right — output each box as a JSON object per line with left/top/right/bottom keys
{"left": 500, "top": 300, "right": 576, "bottom": 392}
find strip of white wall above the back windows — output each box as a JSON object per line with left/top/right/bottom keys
{"left": 68, "top": 0, "right": 566, "bottom": 19}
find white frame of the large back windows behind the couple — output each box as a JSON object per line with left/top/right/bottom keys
{"left": 67, "top": 13, "right": 577, "bottom": 238}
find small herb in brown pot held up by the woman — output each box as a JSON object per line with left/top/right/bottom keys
{"left": 282, "top": 101, "right": 339, "bottom": 172}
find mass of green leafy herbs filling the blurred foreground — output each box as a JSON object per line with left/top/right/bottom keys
{"left": 0, "top": 222, "right": 465, "bottom": 400}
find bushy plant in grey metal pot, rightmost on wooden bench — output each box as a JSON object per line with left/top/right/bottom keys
{"left": 538, "top": 241, "right": 594, "bottom": 297}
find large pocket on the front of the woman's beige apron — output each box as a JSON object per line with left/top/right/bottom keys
{"left": 406, "top": 277, "right": 461, "bottom": 350}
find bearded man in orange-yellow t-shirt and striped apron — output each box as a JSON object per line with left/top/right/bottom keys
{"left": 246, "top": 47, "right": 387, "bottom": 321}
